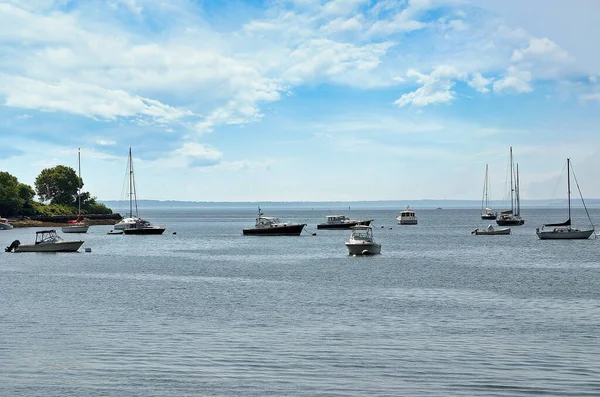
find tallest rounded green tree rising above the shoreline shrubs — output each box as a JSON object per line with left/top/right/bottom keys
{"left": 35, "top": 165, "right": 83, "bottom": 205}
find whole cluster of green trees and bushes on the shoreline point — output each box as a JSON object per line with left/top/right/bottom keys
{"left": 0, "top": 165, "right": 112, "bottom": 216}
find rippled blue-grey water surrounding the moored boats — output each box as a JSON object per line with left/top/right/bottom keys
{"left": 0, "top": 209, "right": 600, "bottom": 396}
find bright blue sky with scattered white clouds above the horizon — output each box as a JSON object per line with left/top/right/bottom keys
{"left": 0, "top": 0, "right": 600, "bottom": 201}
